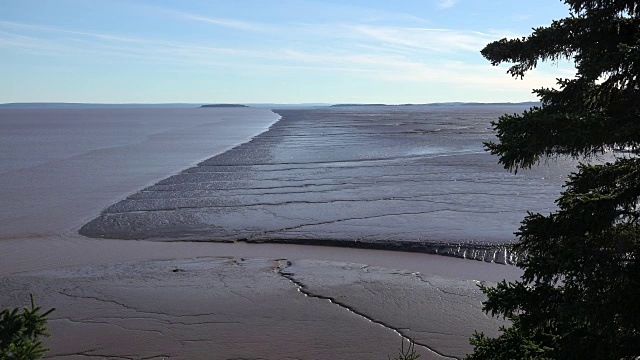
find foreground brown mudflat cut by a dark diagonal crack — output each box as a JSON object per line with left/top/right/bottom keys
{"left": 0, "top": 255, "right": 512, "bottom": 359}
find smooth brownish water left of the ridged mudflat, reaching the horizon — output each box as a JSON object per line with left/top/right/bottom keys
{"left": 0, "top": 108, "right": 278, "bottom": 240}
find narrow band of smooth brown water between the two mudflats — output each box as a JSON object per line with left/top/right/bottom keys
{"left": 0, "top": 235, "right": 521, "bottom": 282}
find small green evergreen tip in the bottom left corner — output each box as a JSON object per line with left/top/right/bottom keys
{"left": 0, "top": 294, "right": 55, "bottom": 360}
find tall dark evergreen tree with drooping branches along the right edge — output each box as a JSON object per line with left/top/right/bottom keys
{"left": 467, "top": 0, "right": 640, "bottom": 360}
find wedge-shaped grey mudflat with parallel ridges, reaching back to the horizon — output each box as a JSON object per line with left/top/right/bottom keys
{"left": 80, "top": 106, "right": 575, "bottom": 263}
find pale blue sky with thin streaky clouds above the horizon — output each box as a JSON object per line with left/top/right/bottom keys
{"left": 0, "top": 0, "right": 574, "bottom": 104}
